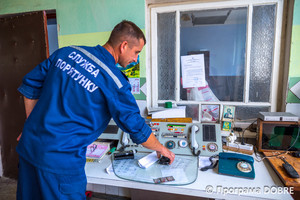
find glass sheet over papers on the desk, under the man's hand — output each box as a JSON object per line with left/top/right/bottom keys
{"left": 112, "top": 152, "right": 198, "bottom": 185}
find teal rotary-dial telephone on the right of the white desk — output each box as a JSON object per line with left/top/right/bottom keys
{"left": 219, "top": 152, "right": 255, "bottom": 179}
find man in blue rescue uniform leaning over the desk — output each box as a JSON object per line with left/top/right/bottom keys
{"left": 17, "top": 21, "right": 175, "bottom": 200}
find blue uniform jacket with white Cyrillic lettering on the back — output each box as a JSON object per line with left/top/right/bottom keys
{"left": 17, "top": 45, "right": 151, "bottom": 174}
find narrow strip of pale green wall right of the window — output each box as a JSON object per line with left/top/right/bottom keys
{"left": 286, "top": 0, "right": 300, "bottom": 117}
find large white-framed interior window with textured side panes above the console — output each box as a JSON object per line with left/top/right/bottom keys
{"left": 147, "top": 0, "right": 283, "bottom": 121}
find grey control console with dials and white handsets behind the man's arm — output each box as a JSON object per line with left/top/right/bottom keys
{"left": 117, "top": 122, "right": 222, "bottom": 156}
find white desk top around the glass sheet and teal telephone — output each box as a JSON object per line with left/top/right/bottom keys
{"left": 85, "top": 156, "right": 293, "bottom": 200}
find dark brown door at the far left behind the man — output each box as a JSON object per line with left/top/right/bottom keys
{"left": 0, "top": 11, "right": 49, "bottom": 178}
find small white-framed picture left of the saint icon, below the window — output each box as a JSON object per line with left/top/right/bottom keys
{"left": 201, "top": 104, "right": 220, "bottom": 123}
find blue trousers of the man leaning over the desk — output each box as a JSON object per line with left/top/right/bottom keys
{"left": 17, "top": 157, "right": 87, "bottom": 200}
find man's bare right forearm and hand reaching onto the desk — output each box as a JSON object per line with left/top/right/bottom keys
{"left": 142, "top": 133, "right": 175, "bottom": 164}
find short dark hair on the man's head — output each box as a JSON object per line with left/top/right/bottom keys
{"left": 108, "top": 20, "right": 146, "bottom": 46}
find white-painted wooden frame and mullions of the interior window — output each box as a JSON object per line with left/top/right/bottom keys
{"left": 146, "top": 0, "right": 284, "bottom": 121}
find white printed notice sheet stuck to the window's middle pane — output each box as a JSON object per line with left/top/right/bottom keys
{"left": 181, "top": 54, "right": 206, "bottom": 88}
